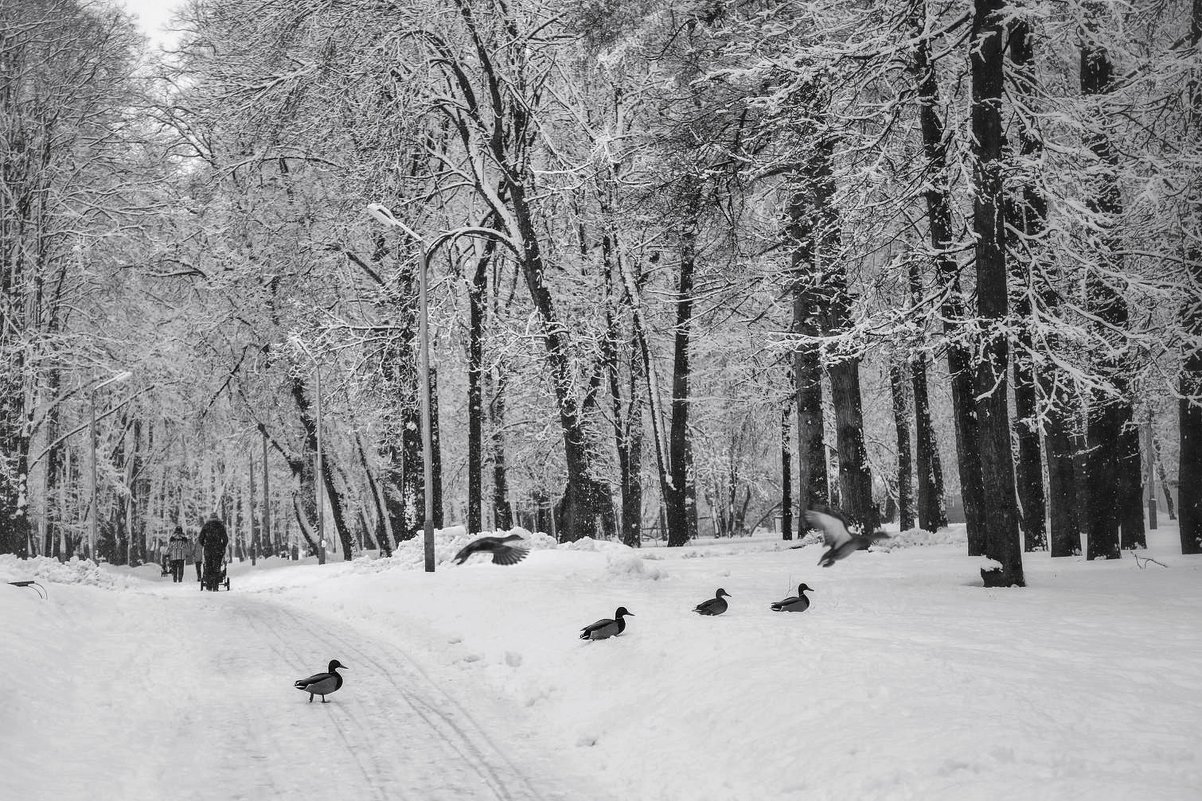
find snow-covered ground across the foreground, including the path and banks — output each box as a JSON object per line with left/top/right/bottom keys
{"left": 0, "top": 527, "right": 1202, "bottom": 801}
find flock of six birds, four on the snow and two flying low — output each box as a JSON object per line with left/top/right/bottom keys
{"left": 294, "top": 508, "right": 888, "bottom": 704}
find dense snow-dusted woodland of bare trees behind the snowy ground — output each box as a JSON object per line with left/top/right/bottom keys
{"left": 0, "top": 0, "right": 1202, "bottom": 585}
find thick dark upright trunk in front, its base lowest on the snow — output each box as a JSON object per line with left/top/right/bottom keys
{"left": 969, "top": 0, "right": 1024, "bottom": 587}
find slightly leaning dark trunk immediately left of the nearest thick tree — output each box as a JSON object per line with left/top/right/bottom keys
{"left": 914, "top": 0, "right": 986, "bottom": 556}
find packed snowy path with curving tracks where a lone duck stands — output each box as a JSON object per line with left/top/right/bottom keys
{"left": 0, "top": 583, "right": 601, "bottom": 801}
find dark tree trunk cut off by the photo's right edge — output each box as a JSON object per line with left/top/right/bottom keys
{"left": 1177, "top": 0, "right": 1202, "bottom": 553}
